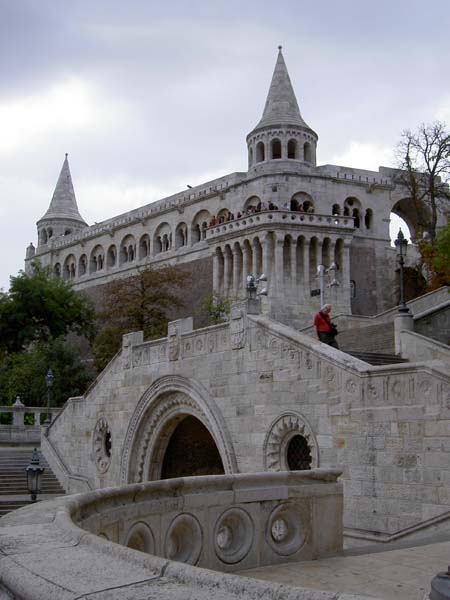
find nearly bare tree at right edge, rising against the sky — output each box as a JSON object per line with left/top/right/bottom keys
{"left": 396, "top": 121, "right": 450, "bottom": 242}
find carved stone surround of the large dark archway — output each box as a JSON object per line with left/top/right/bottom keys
{"left": 120, "top": 375, "right": 237, "bottom": 483}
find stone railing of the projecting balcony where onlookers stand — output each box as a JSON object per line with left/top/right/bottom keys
{"left": 206, "top": 210, "right": 354, "bottom": 241}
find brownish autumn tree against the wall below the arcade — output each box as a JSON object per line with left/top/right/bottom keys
{"left": 93, "top": 266, "right": 188, "bottom": 370}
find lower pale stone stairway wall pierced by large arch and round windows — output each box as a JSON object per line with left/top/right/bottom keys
{"left": 43, "top": 310, "right": 450, "bottom": 537}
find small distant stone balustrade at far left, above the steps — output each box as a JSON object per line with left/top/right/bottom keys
{"left": 0, "top": 401, "right": 60, "bottom": 443}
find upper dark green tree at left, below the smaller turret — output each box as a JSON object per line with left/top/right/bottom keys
{"left": 0, "top": 262, "right": 94, "bottom": 353}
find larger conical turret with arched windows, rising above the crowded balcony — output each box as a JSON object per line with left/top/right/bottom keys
{"left": 247, "top": 46, "right": 318, "bottom": 168}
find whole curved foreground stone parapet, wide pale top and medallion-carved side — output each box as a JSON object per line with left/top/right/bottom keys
{"left": 0, "top": 469, "right": 356, "bottom": 600}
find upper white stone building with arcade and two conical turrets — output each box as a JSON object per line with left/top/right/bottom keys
{"left": 26, "top": 47, "right": 436, "bottom": 326}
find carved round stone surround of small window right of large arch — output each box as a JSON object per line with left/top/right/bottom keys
{"left": 263, "top": 413, "right": 319, "bottom": 471}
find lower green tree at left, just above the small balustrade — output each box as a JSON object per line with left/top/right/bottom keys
{"left": 0, "top": 337, "right": 94, "bottom": 406}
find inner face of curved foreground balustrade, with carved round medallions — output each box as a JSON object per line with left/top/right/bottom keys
{"left": 71, "top": 469, "right": 343, "bottom": 571}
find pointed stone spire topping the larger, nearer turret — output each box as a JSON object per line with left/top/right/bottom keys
{"left": 255, "top": 46, "right": 309, "bottom": 129}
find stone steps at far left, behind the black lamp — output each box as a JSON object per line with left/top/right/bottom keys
{"left": 0, "top": 446, "right": 65, "bottom": 517}
